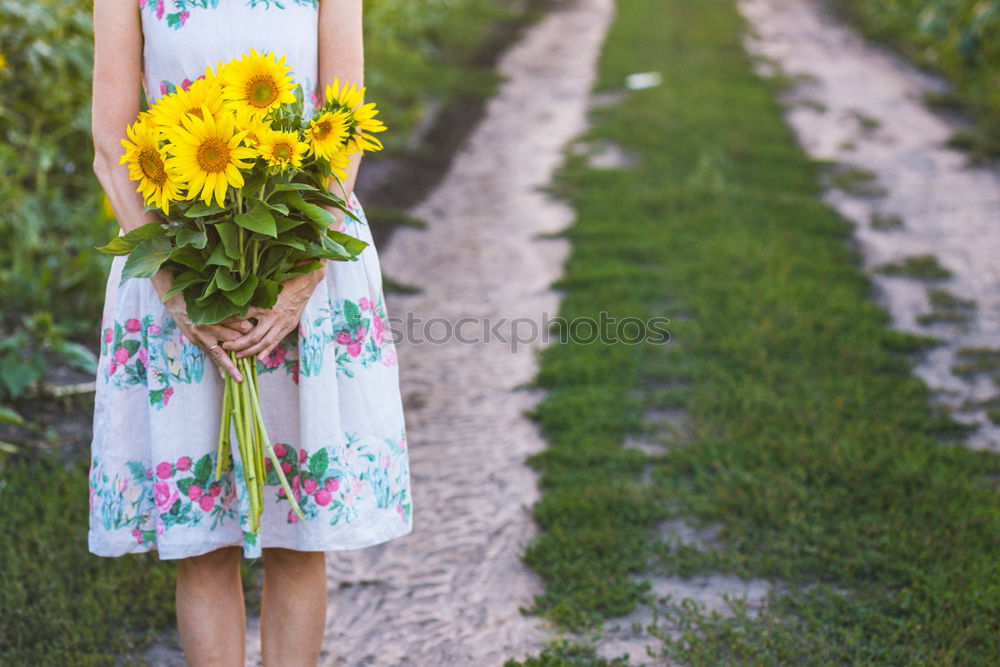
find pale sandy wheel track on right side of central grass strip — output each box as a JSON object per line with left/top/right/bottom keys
{"left": 739, "top": 0, "right": 1000, "bottom": 450}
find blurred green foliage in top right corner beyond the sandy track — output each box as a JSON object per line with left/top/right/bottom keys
{"left": 835, "top": 0, "right": 1000, "bottom": 158}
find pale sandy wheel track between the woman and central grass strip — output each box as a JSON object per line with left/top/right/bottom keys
{"left": 308, "top": 0, "right": 613, "bottom": 666}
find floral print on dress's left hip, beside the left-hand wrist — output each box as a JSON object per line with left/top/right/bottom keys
{"left": 101, "top": 315, "right": 206, "bottom": 409}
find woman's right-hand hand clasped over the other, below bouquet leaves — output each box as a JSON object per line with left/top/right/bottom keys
{"left": 222, "top": 266, "right": 326, "bottom": 361}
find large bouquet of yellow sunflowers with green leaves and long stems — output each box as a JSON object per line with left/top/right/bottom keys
{"left": 99, "top": 50, "right": 386, "bottom": 534}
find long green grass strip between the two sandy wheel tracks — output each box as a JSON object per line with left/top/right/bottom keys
{"left": 524, "top": 0, "right": 1000, "bottom": 665}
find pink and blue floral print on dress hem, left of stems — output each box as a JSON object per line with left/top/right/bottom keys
{"left": 89, "top": 452, "right": 237, "bottom": 545}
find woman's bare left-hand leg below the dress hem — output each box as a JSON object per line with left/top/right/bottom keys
{"left": 177, "top": 547, "right": 246, "bottom": 667}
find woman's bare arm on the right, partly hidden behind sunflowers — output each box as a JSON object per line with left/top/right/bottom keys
{"left": 319, "top": 0, "right": 365, "bottom": 229}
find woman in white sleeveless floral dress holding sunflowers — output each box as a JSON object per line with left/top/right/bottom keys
{"left": 89, "top": 0, "right": 412, "bottom": 665}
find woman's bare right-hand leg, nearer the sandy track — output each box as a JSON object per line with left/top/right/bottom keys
{"left": 260, "top": 548, "right": 327, "bottom": 667}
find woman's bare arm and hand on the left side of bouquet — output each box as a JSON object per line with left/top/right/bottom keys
{"left": 92, "top": 0, "right": 250, "bottom": 381}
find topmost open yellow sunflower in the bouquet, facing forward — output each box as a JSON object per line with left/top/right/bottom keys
{"left": 219, "top": 49, "right": 295, "bottom": 116}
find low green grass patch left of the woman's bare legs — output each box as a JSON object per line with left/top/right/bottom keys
{"left": 0, "top": 454, "right": 176, "bottom": 665}
